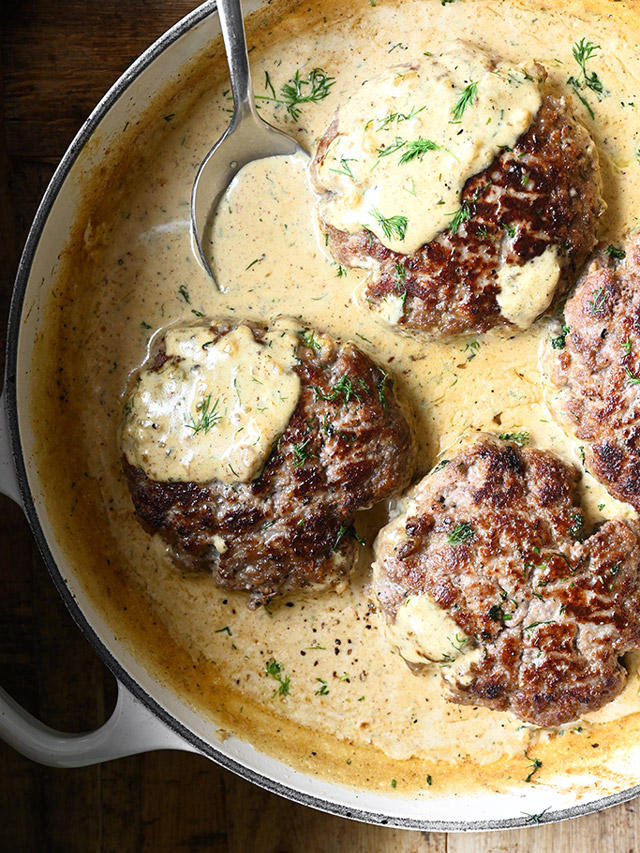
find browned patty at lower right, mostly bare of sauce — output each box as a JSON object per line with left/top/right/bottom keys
{"left": 375, "top": 435, "right": 640, "bottom": 726}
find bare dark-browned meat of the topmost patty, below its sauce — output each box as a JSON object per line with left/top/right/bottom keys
{"left": 312, "top": 95, "right": 603, "bottom": 338}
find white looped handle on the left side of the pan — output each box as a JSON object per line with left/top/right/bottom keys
{"left": 0, "top": 393, "right": 198, "bottom": 767}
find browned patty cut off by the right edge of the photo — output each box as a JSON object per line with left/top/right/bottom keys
{"left": 551, "top": 237, "right": 640, "bottom": 510}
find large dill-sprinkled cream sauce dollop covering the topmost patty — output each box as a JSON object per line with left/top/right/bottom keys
{"left": 318, "top": 41, "right": 542, "bottom": 254}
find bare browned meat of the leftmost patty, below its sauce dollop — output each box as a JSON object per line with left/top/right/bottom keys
{"left": 123, "top": 324, "right": 415, "bottom": 608}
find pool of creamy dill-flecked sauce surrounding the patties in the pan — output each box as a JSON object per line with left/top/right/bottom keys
{"left": 34, "top": 0, "right": 640, "bottom": 790}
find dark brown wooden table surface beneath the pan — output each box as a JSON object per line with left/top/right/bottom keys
{"left": 0, "top": 0, "right": 640, "bottom": 853}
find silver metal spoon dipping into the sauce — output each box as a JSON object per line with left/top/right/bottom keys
{"left": 191, "top": 0, "right": 308, "bottom": 280}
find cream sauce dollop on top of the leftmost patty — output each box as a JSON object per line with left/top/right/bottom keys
{"left": 122, "top": 321, "right": 300, "bottom": 483}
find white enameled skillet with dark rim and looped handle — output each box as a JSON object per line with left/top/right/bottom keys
{"left": 0, "top": 0, "right": 640, "bottom": 831}
